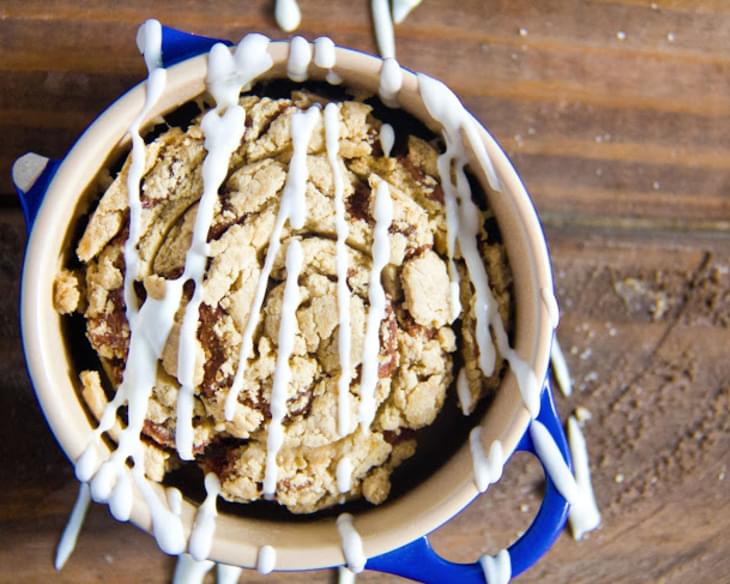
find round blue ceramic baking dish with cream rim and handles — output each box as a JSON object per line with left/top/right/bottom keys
{"left": 13, "top": 29, "right": 570, "bottom": 582}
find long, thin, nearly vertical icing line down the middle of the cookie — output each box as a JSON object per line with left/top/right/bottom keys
{"left": 324, "top": 103, "right": 352, "bottom": 436}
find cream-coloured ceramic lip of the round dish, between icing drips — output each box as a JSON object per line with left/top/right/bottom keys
{"left": 21, "top": 42, "right": 553, "bottom": 570}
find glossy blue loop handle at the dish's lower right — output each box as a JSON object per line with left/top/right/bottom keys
{"left": 365, "top": 382, "right": 572, "bottom": 584}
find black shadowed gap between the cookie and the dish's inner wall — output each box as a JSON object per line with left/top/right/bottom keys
{"left": 63, "top": 80, "right": 515, "bottom": 523}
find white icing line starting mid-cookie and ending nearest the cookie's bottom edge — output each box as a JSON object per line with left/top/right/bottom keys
{"left": 263, "top": 239, "right": 304, "bottom": 498}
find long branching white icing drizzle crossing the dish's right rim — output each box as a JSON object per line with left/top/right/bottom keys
{"left": 418, "top": 74, "right": 541, "bottom": 418}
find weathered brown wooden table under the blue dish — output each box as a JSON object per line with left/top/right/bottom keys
{"left": 0, "top": 0, "right": 730, "bottom": 583}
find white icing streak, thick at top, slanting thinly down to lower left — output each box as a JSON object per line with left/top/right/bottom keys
{"left": 225, "top": 105, "right": 321, "bottom": 420}
